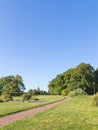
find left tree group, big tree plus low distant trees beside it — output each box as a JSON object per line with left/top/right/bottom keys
{"left": 0, "top": 75, "right": 48, "bottom": 96}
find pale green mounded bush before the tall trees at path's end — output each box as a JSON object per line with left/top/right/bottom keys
{"left": 68, "top": 89, "right": 87, "bottom": 97}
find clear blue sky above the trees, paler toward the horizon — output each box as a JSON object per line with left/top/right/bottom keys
{"left": 0, "top": 0, "right": 98, "bottom": 90}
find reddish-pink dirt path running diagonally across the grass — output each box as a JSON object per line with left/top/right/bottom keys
{"left": 0, "top": 98, "right": 70, "bottom": 126}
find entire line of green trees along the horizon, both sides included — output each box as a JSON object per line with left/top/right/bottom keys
{"left": 0, "top": 63, "right": 98, "bottom": 96}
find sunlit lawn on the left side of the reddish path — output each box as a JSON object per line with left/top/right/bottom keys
{"left": 0, "top": 95, "right": 64, "bottom": 117}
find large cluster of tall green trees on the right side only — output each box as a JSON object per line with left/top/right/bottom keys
{"left": 48, "top": 63, "right": 98, "bottom": 95}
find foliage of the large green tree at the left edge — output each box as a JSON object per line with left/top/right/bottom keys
{"left": 0, "top": 75, "right": 25, "bottom": 93}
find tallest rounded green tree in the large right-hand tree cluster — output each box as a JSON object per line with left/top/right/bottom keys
{"left": 70, "top": 63, "right": 94, "bottom": 94}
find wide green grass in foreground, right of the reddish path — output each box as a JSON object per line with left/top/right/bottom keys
{"left": 0, "top": 96, "right": 98, "bottom": 130}
